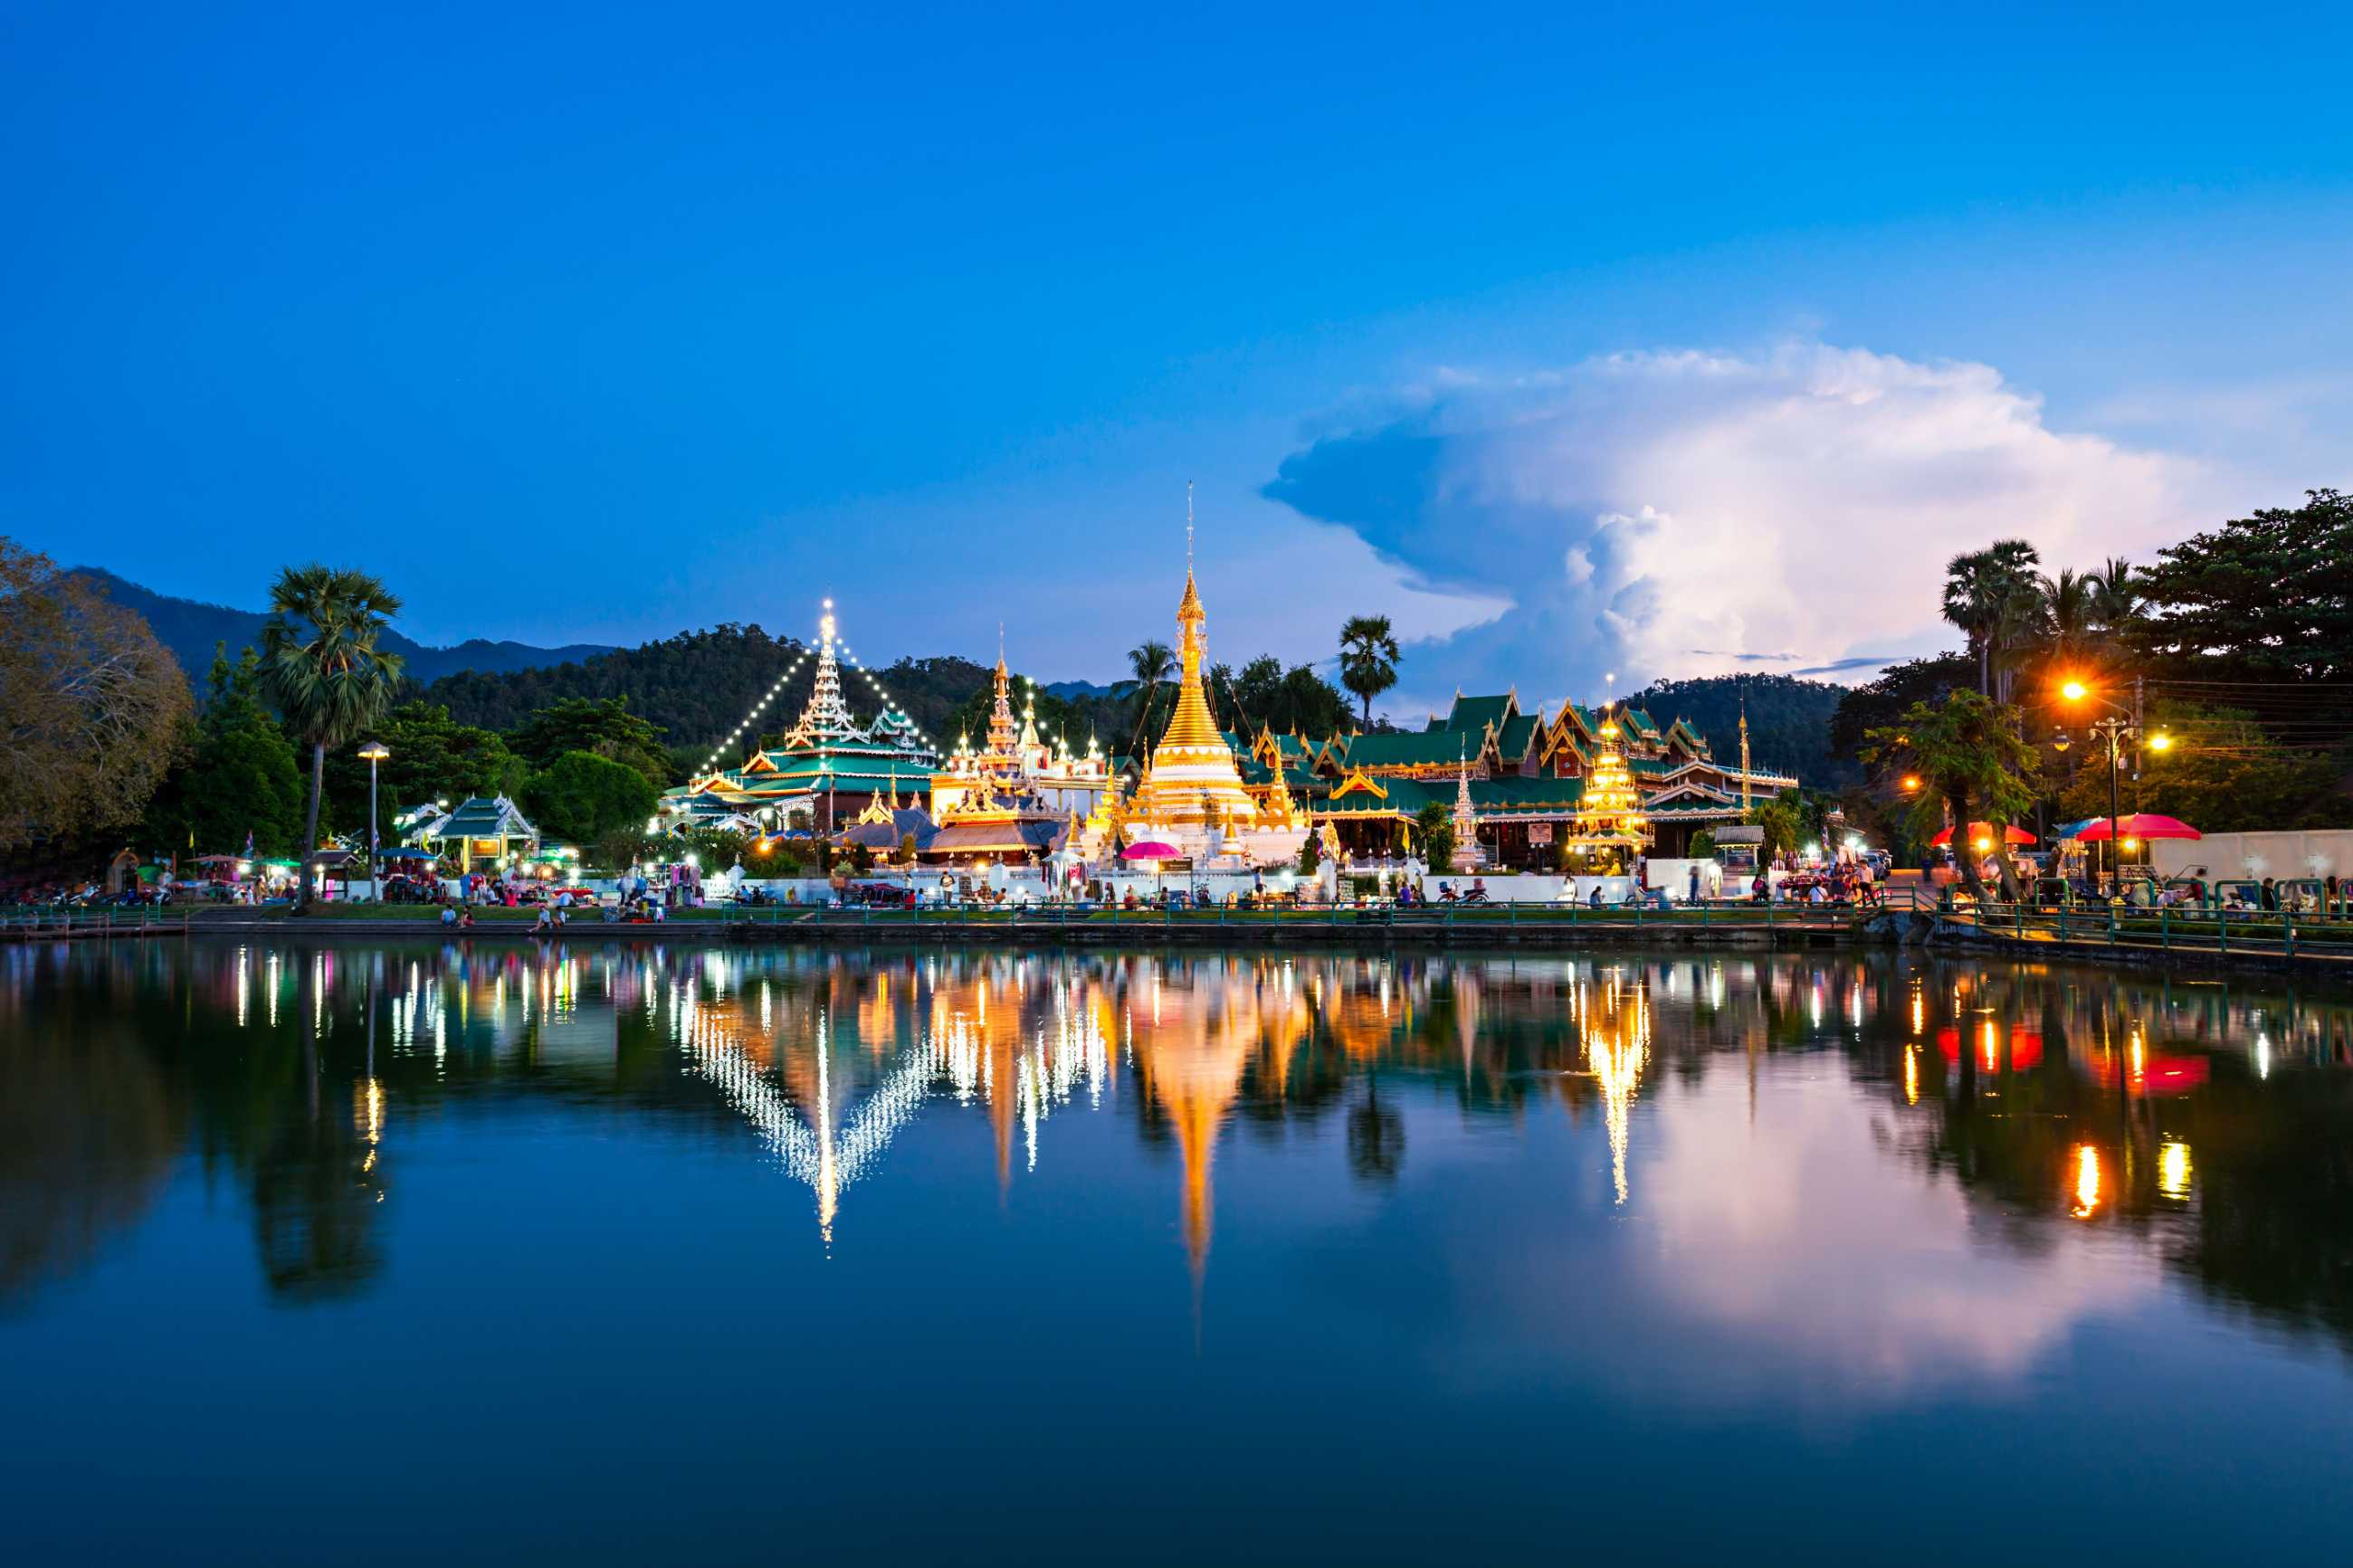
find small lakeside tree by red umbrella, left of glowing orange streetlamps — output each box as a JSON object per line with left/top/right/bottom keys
{"left": 1862, "top": 691, "right": 2040, "bottom": 898}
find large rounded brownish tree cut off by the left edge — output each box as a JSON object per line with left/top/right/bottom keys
{"left": 0, "top": 538, "right": 191, "bottom": 860}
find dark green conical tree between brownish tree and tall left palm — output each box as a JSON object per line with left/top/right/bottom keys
{"left": 144, "top": 644, "right": 303, "bottom": 856}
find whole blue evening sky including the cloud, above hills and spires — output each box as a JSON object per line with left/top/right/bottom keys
{"left": 0, "top": 5, "right": 2353, "bottom": 708}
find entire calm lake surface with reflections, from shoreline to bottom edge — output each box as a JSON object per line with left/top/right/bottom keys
{"left": 0, "top": 943, "right": 2353, "bottom": 1563}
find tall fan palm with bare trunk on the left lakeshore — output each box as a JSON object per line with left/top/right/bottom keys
{"left": 262, "top": 565, "right": 403, "bottom": 908}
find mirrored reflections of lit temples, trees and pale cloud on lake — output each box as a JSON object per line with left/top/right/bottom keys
{"left": 0, "top": 943, "right": 2353, "bottom": 1383}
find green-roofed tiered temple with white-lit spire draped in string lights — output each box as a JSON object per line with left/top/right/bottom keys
{"left": 662, "top": 600, "right": 938, "bottom": 832}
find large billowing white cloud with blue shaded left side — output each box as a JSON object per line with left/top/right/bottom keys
{"left": 1268, "top": 343, "right": 2226, "bottom": 693}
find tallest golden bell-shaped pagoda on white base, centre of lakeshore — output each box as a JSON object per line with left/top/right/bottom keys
{"left": 1122, "top": 524, "right": 1306, "bottom": 865}
